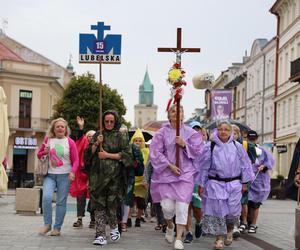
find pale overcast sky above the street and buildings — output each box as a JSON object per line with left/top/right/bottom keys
{"left": 0, "top": 0, "right": 276, "bottom": 124}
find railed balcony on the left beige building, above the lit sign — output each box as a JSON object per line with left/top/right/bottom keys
{"left": 8, "top": 116, "right": 50, "bottom": 132}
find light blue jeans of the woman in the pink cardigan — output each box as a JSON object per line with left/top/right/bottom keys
{"left": 43, "top": 174, "right": 70, "bottom": 230}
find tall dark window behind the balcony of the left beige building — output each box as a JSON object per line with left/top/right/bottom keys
{"left": 19, "top": 90, "right": 32, "bottom": 128}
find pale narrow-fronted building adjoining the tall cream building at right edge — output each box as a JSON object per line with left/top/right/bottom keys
{"left": 245, "top": 39, "right": 276, "bottom": 148}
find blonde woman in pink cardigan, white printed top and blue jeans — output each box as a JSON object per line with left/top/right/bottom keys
{"left": 37, "top": 118, "right": 79, "bottom": 236}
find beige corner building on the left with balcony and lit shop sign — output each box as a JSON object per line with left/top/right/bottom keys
{"left": 0, "top": 33, "right": 72, "bottom": 186}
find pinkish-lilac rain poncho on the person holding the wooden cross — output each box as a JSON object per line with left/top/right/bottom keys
{"left": 150, "top": 123, "right": 203, "bottom": 203}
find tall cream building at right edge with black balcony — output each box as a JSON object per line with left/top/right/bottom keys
{"left": 270, "top": 0, "right": 300, "bottom": 176}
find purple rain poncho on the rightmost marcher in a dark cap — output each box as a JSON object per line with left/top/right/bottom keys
{"left": 248, "top": 145, "right": 275, "bottom": 203}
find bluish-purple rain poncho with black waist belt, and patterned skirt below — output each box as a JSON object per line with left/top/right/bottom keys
{"left": 196, "top": 130, "right": 254, "bottom": 235}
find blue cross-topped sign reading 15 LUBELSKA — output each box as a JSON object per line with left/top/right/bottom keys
{"left": 79, "top": 22, "right": 122, "bottom": 64}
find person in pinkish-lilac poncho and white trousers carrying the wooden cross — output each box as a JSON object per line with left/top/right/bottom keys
{"left": 150, "top": 105, "right": 202, "bottom": 249}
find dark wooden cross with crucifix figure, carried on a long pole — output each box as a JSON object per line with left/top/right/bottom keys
{"left": 157, "top": 28, "right": 200, "bottom": 167}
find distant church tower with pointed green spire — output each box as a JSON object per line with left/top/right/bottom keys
{"left": 134, "top": 69, "right": 157, "bottom": 128}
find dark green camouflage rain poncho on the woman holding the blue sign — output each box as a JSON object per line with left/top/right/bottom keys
{"left": 85, "top": 111, "right": 133, "bottom": 210}
